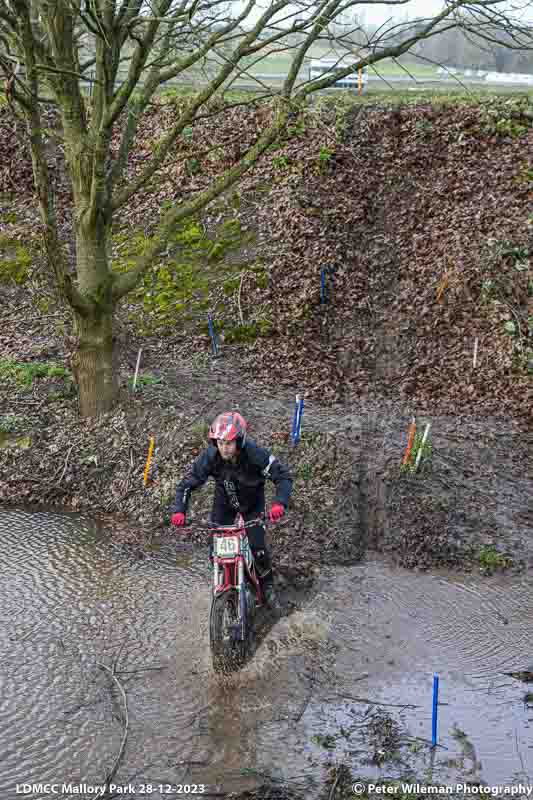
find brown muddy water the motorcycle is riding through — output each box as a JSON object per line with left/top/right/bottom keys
{"left": 0, "top": 511, "right": 533, "bottom": 798}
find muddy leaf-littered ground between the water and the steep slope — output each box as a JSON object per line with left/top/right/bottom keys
{"left": 0, "top": 344, "right": 533, "bottom": 573}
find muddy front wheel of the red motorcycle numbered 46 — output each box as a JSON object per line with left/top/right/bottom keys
{"left": 209, "top": 591, "right": 248, "bottom": 674}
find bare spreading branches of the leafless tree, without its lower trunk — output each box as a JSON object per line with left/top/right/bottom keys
{"left": 7, "top": 0, "right": 532, "bottom": 334}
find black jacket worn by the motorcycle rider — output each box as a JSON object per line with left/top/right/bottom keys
{"left": 170, "top": 439, "right": 292, "bottom": 514}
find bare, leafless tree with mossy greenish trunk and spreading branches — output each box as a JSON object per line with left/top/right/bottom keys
{"left": 0, "top": 0, "right": 530, "bottom": 416}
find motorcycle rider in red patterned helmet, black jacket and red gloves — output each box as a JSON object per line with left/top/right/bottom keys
{"left": 170, "top": 411, "right": 292, "bottom": 611}
